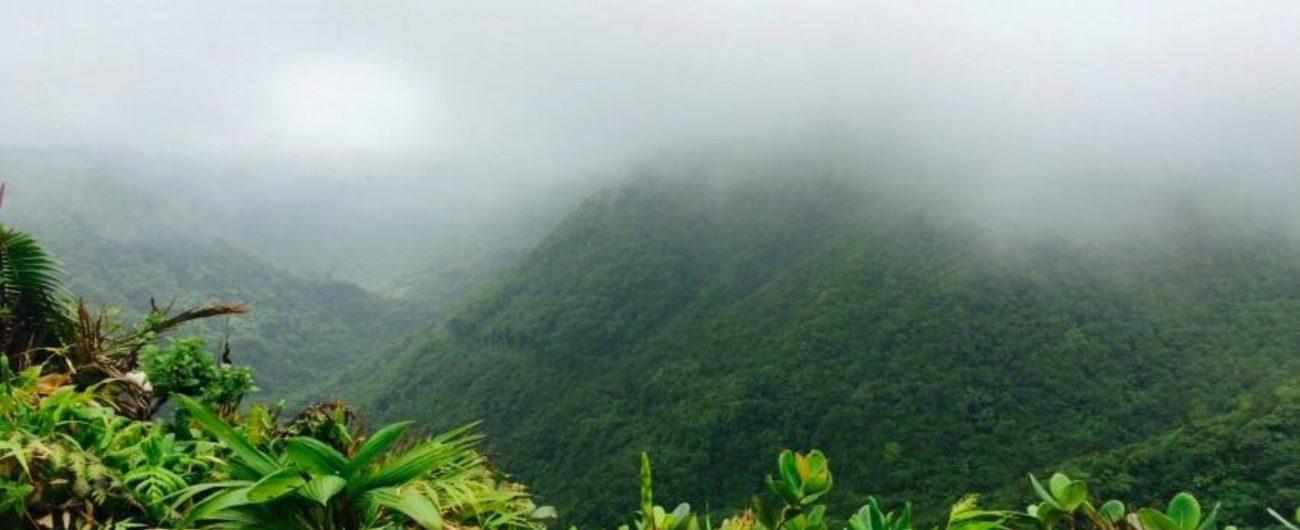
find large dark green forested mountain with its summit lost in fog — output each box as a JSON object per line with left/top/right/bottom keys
{"left": 354, "top": 179, "right": 1300, "bottom": 522}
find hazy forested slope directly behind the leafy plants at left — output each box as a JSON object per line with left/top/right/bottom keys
{"left": 0, "top": 157, "right": 433, "bottom": 404}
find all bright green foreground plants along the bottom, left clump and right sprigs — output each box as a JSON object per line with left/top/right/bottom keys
{"left": 0, "top": 201, "right": 1295, "bottom": 530}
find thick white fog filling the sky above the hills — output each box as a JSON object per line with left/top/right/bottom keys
{"left": 0, "top": 0, "right": 1300, "bottom": 279}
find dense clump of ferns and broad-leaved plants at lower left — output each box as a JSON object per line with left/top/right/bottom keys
{"left": 0, "top": 226, "right": 553, "bottom": 530}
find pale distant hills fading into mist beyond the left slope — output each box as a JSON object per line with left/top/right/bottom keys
{"left": 0, "top": 145, "right": 572, "bottom": 302}
